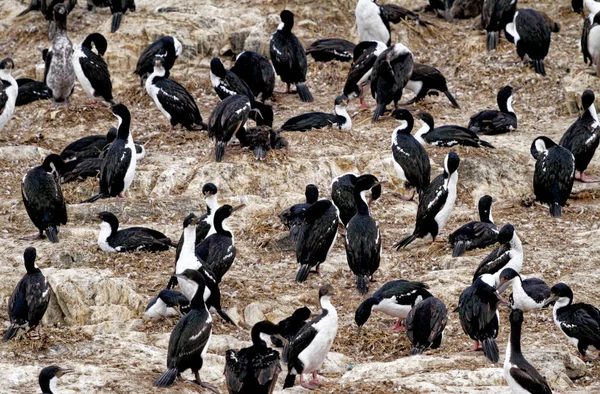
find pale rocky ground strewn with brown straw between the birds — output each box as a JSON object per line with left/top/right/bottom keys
{"left": 0, "top": 0, "right": 600, "bottom": 394}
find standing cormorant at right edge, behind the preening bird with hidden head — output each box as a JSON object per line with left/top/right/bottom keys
{"left": 559, "top": 90, "right": 600, "bottom": 182}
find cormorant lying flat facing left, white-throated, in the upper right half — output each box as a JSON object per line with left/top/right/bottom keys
{"left": 415, "top": 112, "right": 494, "bottom": 148}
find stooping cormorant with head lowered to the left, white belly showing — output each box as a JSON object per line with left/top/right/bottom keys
{"left": 354, "top": 279, "right": 431, "bottom": 332}
